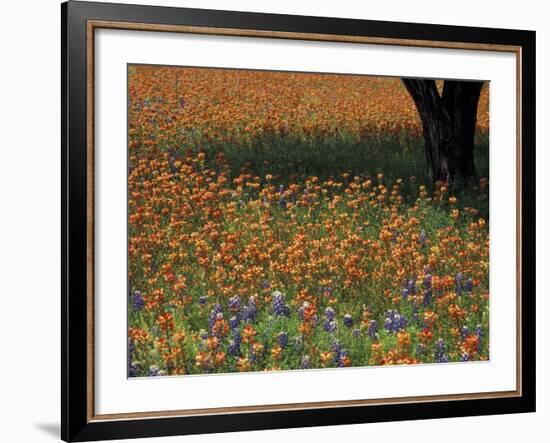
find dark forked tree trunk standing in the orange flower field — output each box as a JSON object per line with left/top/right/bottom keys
{"left": 402, "top": 78, "right": 483, "bottom": 186}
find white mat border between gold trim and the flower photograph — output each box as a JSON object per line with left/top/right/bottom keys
{"left": 94, "top": 29, "right": 516, "bottom": 414}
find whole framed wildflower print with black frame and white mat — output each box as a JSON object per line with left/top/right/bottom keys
{"left": 61, "top": 1, "right": 535, "bottom": 441}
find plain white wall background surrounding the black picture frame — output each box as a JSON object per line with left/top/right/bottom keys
{"left": 0, "top": 0, "right": 550, "bottom": 443}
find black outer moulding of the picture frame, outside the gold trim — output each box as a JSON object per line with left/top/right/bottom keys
{"left": 61, "top": 1, "right": 535, "bottom": 441}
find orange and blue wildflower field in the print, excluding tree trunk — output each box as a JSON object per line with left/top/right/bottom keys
{"left": 128, "top": 66, "right": 489, "bottom": 377}
